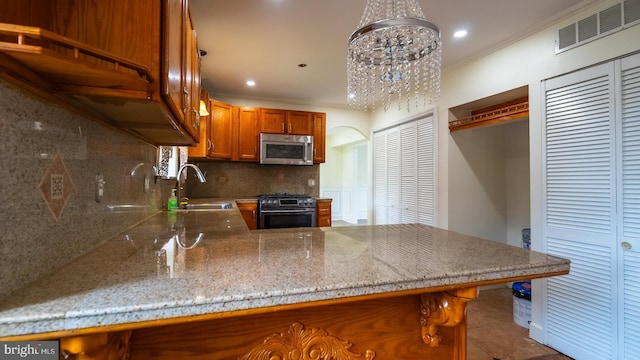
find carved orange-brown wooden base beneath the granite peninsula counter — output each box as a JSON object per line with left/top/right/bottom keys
{"left": 61, "top": 287, "right": 477, "bottom": 360}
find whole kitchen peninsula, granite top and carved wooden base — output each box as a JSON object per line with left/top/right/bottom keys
{"left": 0, "top": 206, "right": 569, "bottom": 359}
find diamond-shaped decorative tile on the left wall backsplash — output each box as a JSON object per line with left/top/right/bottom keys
{"left": 39, "top": 153, "right": 73, "bottom": 221}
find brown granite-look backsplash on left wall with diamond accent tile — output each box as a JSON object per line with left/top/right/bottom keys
{"left": 0, "top": 80, "right": 175, "bottom": 298}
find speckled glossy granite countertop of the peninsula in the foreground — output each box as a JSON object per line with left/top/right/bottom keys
{"left": 0, "top": 202, "right": 569, "bottom": 338}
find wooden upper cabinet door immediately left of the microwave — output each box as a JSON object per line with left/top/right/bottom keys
{"left": 234, "top": 107, "right": 260, "bottom": 161}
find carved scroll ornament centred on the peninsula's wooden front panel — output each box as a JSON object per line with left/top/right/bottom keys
{"left": 241, "top": 322, "right": 376, "bottom": 360}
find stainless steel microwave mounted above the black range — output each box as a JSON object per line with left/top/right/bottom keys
{"left": 260, "top": 134, "right": 313, "bottom": 165}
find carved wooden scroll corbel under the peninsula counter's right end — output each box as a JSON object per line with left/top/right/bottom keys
{"left": 420, "top": 288, "right": 477, "bottom": 347}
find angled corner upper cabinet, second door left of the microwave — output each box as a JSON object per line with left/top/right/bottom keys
{"left": 208, "top": 100, "right": 234, "bottom": 159}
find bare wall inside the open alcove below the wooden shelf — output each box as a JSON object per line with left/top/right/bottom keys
{"left": 449, "top": 119, "right": 531, "bottom": 246}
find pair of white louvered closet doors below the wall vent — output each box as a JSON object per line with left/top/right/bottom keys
{"left": 543, "top": 51, "right": 640, "bottom": 359}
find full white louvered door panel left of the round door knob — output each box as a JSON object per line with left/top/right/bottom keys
{"left": 543, "top": 64, "right": 618, "bottom": 359}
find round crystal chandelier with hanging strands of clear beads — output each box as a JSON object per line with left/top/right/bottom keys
{"left": 347, "top": 0, "right": 441, "bottom": 111}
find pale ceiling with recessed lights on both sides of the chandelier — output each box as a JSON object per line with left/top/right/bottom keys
{"left": 190, "top": 0, "right": 597, "bottom": 107}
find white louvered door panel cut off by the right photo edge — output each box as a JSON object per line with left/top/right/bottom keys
{"left": 618, "top": 55, "right": 640, "bottom": 359}
